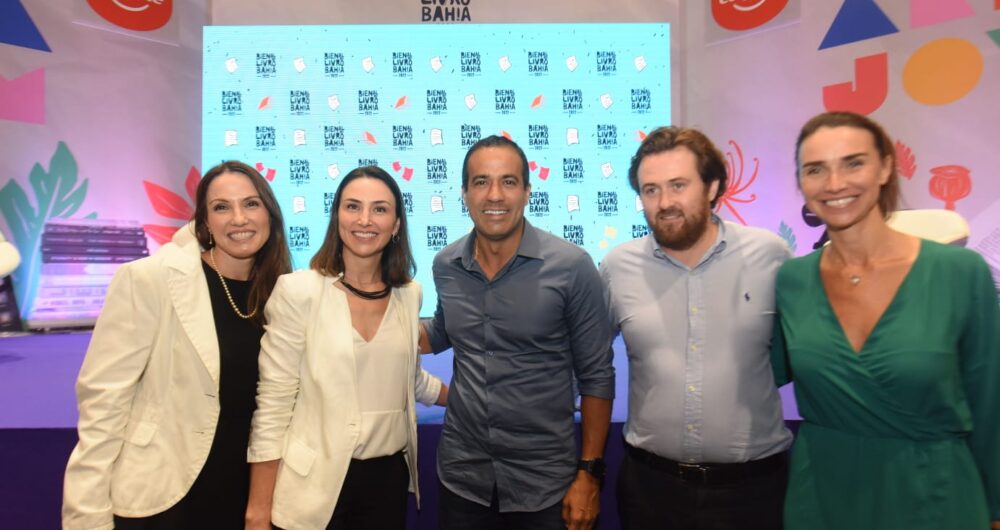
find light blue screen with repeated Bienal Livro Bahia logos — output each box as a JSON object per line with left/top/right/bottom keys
{"left": 202, "top": 24, "right": 671, "bottom": 316}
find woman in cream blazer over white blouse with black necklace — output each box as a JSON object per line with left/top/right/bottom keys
{"left": 247, "top": 166, "right": 447, "bottom": 530}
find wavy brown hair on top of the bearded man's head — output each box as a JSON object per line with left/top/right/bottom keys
{"left": 628, "top": 125, "right": 729, "bottom": 208}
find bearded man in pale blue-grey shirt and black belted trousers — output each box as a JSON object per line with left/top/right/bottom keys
{"left": 600, "top": 127, "right": 792, "bottom": 530}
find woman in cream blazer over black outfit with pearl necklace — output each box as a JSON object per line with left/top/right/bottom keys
{"left": 62, "top": 162, "right": 291, "bottom": 529}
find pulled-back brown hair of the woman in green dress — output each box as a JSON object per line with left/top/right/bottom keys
{"left": 795, "top": 111, "right": 899, "bottom": 219}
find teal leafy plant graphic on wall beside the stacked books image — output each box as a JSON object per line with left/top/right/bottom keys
{"left": 0, "top": 142, "right": 97, "bottom": 316}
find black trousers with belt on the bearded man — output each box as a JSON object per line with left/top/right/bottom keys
{"left": 617, "top": 451, "right": 788, "bottom": 530}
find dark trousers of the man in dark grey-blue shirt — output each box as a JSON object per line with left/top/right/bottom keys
{"left": 438, "top": 482, "right": 566, "bottom": 530}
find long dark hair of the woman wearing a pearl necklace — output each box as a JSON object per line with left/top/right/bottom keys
{"left": 193, "top": 160, "right": 292, "bottom": 325}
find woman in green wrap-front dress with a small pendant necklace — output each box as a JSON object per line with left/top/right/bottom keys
{"left": 773, "top": 112, "right": 1000, "bottom": 530}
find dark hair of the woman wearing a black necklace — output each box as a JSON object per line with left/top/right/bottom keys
{"left": 309, "top": 166, "right": 417, "bottom": 287}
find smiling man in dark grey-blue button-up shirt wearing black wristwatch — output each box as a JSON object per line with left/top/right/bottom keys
{"left": 422, "top": 136, "right": 614, "bottom": 530}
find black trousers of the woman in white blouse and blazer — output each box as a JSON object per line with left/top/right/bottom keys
{"left": 326, "top": 452, "right": 410, "bottom": 530}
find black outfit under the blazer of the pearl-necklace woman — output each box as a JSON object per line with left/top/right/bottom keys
{"left": 115, "top": 262, "right": 264, "bottom": 530}
